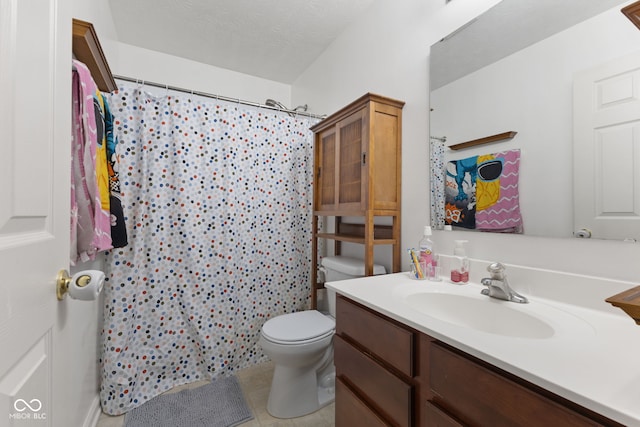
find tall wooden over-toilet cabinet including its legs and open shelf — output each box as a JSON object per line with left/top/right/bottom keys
{"left": 311, "top": 93, "right": 404, "bottom": 308}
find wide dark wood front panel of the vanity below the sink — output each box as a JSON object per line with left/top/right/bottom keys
{"left": 429, "top": 344, "right": 605, "bottom": 427}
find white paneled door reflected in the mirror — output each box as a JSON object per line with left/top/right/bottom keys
{"left": 573, "top": 53, "right": 640, "bottom": 241}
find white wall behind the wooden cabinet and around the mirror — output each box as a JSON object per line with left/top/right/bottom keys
{"left": 292, "top": 0, "right": 640, "bottom": 281}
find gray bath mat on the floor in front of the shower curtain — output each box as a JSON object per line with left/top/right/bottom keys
{"left": 124, "top": 376, "right": 253, "bottom": 427}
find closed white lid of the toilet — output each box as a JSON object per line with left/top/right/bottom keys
{"left": 262, "top": 310, "right": 336, "bottom": 342}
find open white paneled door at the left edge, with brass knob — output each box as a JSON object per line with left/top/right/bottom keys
{"left": 0, "top": 0, "right": 71, "bottom": 426}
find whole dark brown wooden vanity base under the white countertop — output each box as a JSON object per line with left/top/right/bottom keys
{"left": 334, "top": 296, "right": 621, "bottom": 427}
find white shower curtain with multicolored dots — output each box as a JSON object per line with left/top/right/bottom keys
{"left": 100, "top": 84, "right": 315, "bottom": 415}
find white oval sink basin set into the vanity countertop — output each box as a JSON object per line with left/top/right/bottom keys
{"left": 405, "top": 292, "right": 555, "bottom": 339}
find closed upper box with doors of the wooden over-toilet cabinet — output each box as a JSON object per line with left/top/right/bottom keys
{"left": 311, "top": 94, "right": 404, "bottom": 215}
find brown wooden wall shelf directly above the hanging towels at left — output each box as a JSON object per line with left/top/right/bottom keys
{"left": 73, "top": 19, "right": 118, "bottom": 93}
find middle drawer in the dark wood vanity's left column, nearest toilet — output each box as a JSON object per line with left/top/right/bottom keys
{"left": 333, "top": 336, "right": 413, "bottom": 427}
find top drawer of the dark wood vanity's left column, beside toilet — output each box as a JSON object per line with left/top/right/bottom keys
{"left": 336, "top": 296, "right": 415, "bottom": 377}
